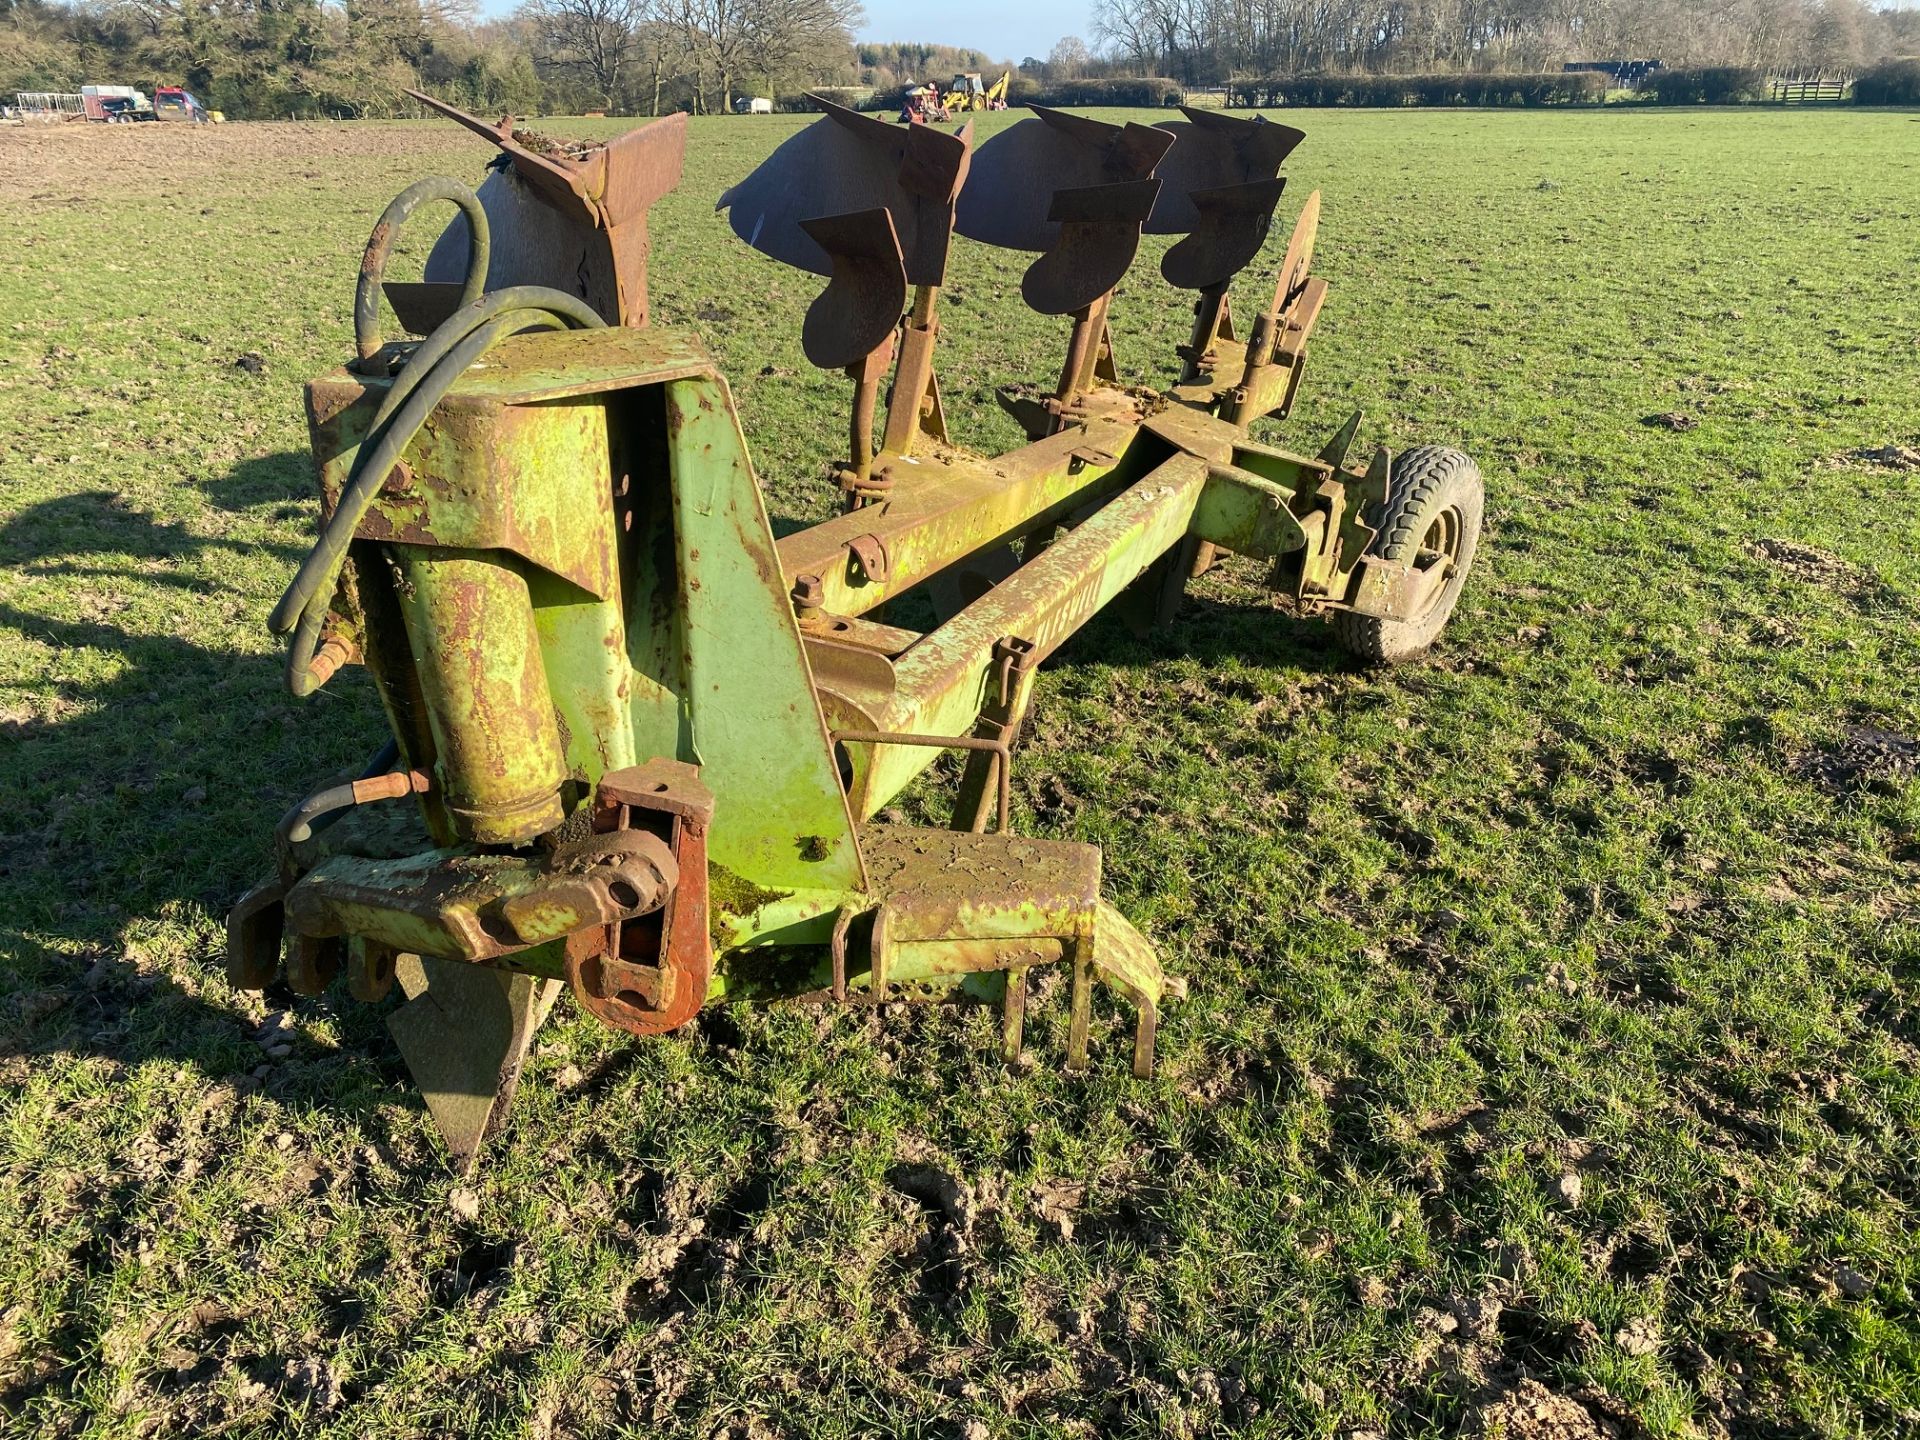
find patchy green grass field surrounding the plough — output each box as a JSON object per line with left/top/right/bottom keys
{"left": 0, "top": 111, "right": 1920, "bottom": 1440}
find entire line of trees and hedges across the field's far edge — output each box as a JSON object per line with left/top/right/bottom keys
{"left": 0, "top": 0, "right": 1920, "bottom": 119}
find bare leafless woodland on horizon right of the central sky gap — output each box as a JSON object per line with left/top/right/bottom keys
{"left": 1092, "top": 0, "right": 1920, "bottom": 86}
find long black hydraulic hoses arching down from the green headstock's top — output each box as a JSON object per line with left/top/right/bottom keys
{"left": 267, "top": 286, "right": 607, "bottom": 697}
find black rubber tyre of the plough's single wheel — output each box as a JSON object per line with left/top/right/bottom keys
{"left": 1332, "top": 445, "right": 1486, "bottom": 664}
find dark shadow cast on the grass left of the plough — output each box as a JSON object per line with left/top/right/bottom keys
{"left": 0, "top": 480, "right": 397, "bottom": 1104}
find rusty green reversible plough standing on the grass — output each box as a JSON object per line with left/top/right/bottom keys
{"left": 228, "top": 96, "right": 1480, "bottom": 1167}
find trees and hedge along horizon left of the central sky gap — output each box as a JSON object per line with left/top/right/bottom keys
{"left": 0, "top": 0, "right": 870, "bottom": 119}
